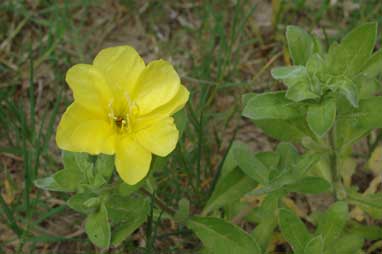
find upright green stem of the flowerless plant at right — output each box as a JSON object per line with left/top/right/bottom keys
{"left": 329, "top": 126, "right": 346, "bottom": 200}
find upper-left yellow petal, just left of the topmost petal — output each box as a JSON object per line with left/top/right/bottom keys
{"left": 66, "top": 64, "right": 112, "bottom": 112}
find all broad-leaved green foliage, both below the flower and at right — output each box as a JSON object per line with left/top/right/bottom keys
{"left": 35, "top": 23, "right": 382, "bottom": 254}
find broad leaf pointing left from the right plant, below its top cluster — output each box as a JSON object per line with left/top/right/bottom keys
{"left": 242, "top": 92, "right": 304, "bottom": 120}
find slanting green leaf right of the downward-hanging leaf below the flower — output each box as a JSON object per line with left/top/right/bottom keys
{"left": 111, "top": 199, "right": 150, "bottom": 246}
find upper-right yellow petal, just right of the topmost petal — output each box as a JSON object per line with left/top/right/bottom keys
{"left": 131, "top": 60, "right": 180, "bottom": 115}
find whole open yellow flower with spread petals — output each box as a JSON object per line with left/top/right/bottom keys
{"left": 56, "top": 46, "right": 189, "bottom": 184}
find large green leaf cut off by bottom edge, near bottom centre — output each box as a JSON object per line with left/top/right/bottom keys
{"left": 188, "top": 217, "right": 261, "bottom": 254}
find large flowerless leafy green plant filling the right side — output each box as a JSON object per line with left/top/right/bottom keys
{"left": 191, "top": 23, "right": 382, "bottom": 254}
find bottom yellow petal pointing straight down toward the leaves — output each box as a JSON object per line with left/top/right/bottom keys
{"left": 115, "top": 136, "right": 151, "bottom": 185}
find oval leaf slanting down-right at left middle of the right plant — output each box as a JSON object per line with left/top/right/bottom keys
{"left": 234, "top": 146, "right": 269, "bottom": 184}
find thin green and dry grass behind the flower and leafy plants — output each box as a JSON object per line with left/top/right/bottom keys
{"left": 0, "top": 0, "right": 382, "bottom": 253}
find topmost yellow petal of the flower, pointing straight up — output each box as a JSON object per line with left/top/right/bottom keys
{"left": 93, "top": 46, "right": 145, "bottom": 94}
